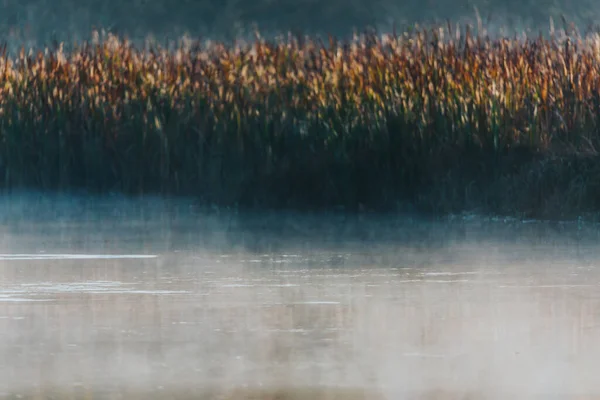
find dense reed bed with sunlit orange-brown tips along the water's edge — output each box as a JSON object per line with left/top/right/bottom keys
{"left": 0, "top": 27, "right": 600, "bottom": 217}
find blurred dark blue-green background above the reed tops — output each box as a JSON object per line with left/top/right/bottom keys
{"left": 0, "top": 0, "right": 600, "bottom": 45}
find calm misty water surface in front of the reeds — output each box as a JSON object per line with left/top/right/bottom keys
{"left": 0, "top": 195, "right": 600, "bottom": 400}
